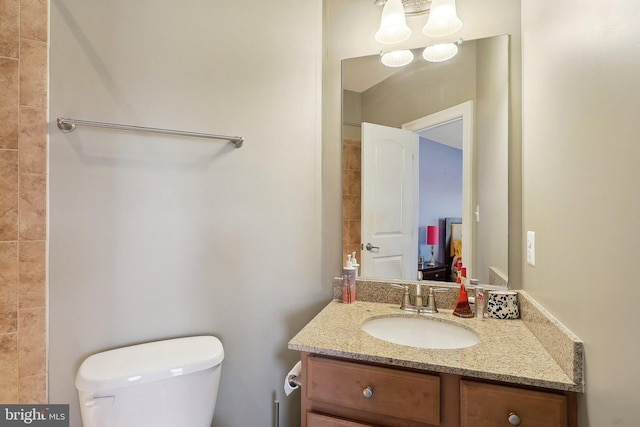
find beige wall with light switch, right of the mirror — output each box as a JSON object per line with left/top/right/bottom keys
{"left": 522, "top": 0, "right": 640, "bottom": 427}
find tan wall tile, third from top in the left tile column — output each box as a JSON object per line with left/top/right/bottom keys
{"left": 0, "top": 150, "right": 18, "bottom": 242}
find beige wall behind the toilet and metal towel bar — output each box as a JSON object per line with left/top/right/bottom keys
{"left": 49, "top": 0, "right": 324, "bottom": 427}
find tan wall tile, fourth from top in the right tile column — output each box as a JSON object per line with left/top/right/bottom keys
{"left": 19, "top": 174, "right": 47, "bottom": 240}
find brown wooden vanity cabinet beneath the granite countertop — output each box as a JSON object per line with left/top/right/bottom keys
{"left": 301, "top": 353, "right": 577, "bottom": 427}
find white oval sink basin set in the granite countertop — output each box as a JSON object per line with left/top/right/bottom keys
{"left": 361, "top": 317, "right": 480, "bottom": 349}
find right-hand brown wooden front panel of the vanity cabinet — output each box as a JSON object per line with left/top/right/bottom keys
{"left": 460, "top": 380, "right": 568, "bottom": 427}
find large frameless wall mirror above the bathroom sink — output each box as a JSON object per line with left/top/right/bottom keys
{"left": 342, "top": 35, "right": 509, "bottom": 286}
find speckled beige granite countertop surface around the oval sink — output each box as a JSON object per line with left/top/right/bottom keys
{"left": 289, "top": 301, "right": 584, "bottom": 392}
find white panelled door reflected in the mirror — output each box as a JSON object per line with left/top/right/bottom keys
{"left": 360, "top": 123, "right": 418, "bottom": 280}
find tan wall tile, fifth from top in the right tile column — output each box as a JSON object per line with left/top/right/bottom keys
{"left": 18, "top": 242, "right": 47, "bottom": 309}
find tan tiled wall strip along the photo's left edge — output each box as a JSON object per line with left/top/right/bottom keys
{"left": 0, "top": 0, "right": 49, "bottom": 403}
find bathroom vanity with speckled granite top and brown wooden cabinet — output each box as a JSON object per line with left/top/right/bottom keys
{"left": 289, "top": 280, "right": 584, "bottom": 427}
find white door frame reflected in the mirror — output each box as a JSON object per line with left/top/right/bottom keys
{"left": 402, "top": 101, "right": 475, "bottom": 277}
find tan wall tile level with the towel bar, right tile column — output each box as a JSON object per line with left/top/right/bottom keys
{"left": 18, "top": 106, "right": 47, "bottom": 174}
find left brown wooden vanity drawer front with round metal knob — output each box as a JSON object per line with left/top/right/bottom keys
{"left": 306, "top": 357, "right": 440, "bottom": 425}
